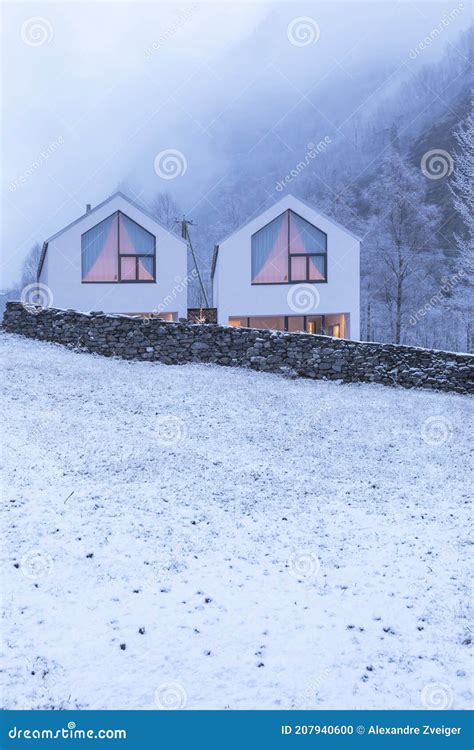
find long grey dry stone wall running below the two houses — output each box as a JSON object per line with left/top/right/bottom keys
{"left": 3, "top": 302, "right": 474, "bottom": 393}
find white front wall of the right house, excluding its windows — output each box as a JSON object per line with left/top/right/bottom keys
{"left": 214, "top": 195, "right": 360, "bottom": 340}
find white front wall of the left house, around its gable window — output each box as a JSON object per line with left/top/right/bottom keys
{"left": 40, "top": 196, "right": 187, "bottom": 318}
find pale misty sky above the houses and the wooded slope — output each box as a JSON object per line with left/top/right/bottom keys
{"left": 2, "top": 0, "right": 470, "bottom": 285}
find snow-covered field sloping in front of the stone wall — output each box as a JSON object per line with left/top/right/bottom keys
{"left": 1, "top": 334, "right": 472, "bottom": 709}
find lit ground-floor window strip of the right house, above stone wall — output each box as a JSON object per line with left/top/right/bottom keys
{"left": 229, "top": 313, "right": 349, "bottom": 338}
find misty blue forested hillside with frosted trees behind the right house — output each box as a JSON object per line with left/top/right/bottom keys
{"left": 176, "top": 33, "right": 472, "bottom": 351}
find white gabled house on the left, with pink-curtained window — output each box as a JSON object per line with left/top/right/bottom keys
{"left": 38, "top": 193, "right": 187, "bottom": 320}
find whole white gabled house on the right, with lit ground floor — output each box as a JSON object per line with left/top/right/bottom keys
{"left": 212, "top": 195, "right": 360, "bottom": 339}
